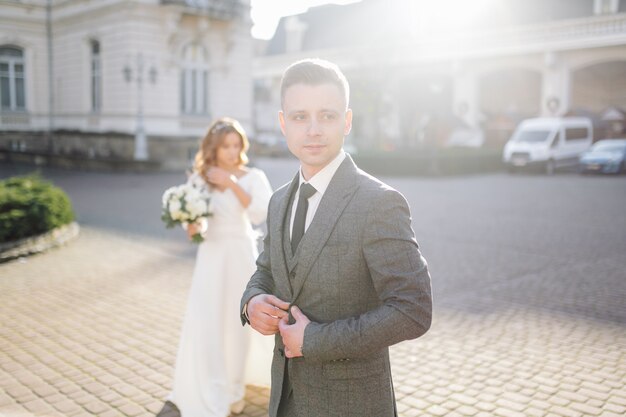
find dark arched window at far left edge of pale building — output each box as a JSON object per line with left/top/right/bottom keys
{"left": 0, "top": 46, "right": 26, "bottom": 111}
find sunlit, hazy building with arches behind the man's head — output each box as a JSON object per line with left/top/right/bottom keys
{"left": 254, "top": 0, "right": 626, "bottom": 150}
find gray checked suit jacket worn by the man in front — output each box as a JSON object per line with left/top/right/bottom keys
{"left": 241, "top": 156, "right": 432, "bottom": 417}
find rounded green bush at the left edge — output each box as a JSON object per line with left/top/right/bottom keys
{"left": 0, "top": 175, "right": 74, "bottom": 242}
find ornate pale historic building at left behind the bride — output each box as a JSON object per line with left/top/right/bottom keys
{"left": 0, "top": 0, "right": 253, "bottom": 166}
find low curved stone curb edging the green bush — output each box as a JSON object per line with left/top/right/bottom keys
{"left": 0, "top": 222, "right": 80, "bottom": 263}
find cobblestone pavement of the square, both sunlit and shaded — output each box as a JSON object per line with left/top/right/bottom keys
{"left": 0, "top": 160, "right": 626, "bottom": 417}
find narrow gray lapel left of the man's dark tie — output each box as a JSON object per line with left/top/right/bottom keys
{"left": 270, "top": 173, "right": 300, "bottom": 299}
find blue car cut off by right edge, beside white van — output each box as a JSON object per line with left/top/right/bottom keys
{"left": 578, "top": 139, "right": 626, "bottom": 174}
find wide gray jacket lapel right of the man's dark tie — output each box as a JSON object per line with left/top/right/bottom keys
{"left": 292, "top": 155, "right": 357, "bottom": 301}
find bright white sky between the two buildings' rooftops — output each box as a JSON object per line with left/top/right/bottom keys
{"left": 250, "top": 0, "right": 360, "bottom": 39}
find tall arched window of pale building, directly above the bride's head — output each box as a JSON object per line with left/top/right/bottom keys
{"left": 180, "top": 44, "right": 209, "bottom": 114}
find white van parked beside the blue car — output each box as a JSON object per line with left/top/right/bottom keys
{"left": 502, "top": 117, "right": 593, "bottom": 174}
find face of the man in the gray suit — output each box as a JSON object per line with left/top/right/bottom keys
{"left": 279, "top": 83, "right": 352, "bottom": 180}
